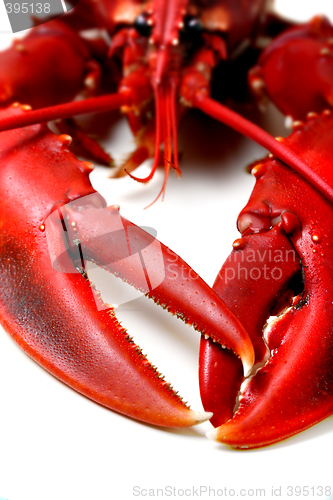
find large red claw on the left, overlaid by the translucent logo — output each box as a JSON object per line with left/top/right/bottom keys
{"left": 0, "top": 106, "right": 253, "bottom": 427}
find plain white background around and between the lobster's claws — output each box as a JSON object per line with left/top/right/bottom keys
{"left": 0, "top": 0, "right": 333, "bottom": 500}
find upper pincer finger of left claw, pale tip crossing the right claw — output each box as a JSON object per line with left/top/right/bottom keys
{"left": 51, "top": 195, "right": 254, "bottom": 374}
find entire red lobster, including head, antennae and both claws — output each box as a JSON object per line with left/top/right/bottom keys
{"left": 0, "top": 0, "right": 333, "bottom": 448}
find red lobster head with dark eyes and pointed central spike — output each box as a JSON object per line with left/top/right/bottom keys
{"left": 106, "top": 0, "right": 264, "bottom": 192}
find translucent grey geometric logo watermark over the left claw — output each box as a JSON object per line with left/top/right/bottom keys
{"left": 43, "top": 194, "right": 166, "bottom": 310}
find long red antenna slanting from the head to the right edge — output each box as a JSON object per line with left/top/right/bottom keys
{"left": 193, "top": 92, "right": 333, "bottom": 203}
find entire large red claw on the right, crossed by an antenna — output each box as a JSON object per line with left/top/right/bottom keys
{"left": 202, "top": 112, "right": 333, "bottom": 448}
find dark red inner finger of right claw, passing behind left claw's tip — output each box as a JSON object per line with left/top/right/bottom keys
{"left": 199, "top": 226, "right": 300, "bottom": 427}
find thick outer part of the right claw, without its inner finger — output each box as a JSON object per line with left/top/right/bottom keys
{"left": 205, "top": 112, "right": 333, "bottom": 448}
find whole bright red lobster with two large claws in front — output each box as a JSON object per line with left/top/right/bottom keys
{"left": 0, "top": 0, "right": 333, "bottom": 448}
